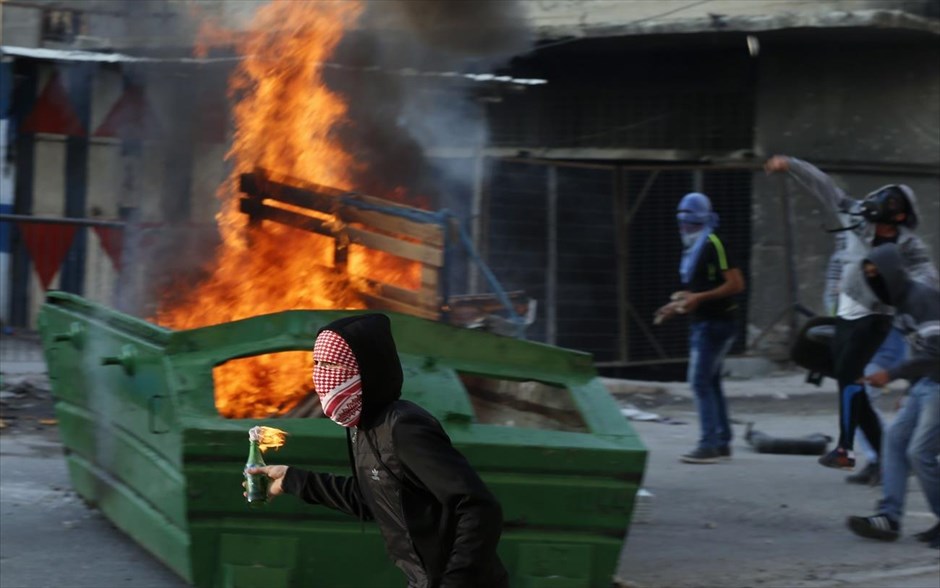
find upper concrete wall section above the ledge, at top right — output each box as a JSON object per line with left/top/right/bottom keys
{"left": 755, "top": 37, "right": 940, "bottom": 165}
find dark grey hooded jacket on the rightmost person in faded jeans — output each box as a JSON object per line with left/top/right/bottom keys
{"left": 859, "top": 243, "right": 940, "bottom": 383}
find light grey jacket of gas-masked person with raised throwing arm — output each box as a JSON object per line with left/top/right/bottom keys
{"left": 787, "top": 157, "right": 940, "bottom": 314}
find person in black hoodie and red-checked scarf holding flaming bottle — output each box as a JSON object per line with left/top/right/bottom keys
{"left": 242, "top": 314, "right": 509, "bottom": 588}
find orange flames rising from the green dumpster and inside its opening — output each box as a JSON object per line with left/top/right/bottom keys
{"left": 156, "top": 0, "right": 420, "bottom": 418}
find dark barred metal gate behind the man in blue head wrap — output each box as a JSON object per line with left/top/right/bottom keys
{"left": 484, "top": 161, "right": 751, "bottom": 365}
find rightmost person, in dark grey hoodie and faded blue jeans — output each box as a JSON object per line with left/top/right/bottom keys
{"left": 848, "top": 244, "right": 940, "bottom": 548}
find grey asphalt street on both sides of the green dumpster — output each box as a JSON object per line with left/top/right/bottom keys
{"left": 0, "top": 342, "right": 940, "bottom": 588}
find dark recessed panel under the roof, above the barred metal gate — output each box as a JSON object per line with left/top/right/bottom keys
{"left": 487, "top": 46, "right": 755, "bottom": 153}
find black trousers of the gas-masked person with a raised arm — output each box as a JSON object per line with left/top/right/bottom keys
{"left": 832, "top": 314, "right": 891, "bottom": 455}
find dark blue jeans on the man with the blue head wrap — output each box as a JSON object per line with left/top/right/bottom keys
{"left": 688, "top": 319, "right": 735, "bottom": 449}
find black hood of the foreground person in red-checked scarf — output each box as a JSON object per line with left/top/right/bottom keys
{"left": 317, "top": 313, "right": 404, "bottom": 428}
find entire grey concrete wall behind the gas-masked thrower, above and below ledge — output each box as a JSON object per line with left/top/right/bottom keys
{"left": 751, "top": 40, "right": 940, "bottom": 350}
